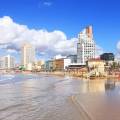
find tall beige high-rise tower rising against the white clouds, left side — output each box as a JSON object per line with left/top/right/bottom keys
{"left": 21, "top": 43, "right": 35, "bottom": 69}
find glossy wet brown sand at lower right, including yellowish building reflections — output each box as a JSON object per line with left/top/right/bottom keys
{"left": 75, "top": 80, "right": 120, "bottom": 120}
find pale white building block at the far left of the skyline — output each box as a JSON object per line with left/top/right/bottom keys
{"left": 0, "top": 55, "right": 15, "bottom": 69}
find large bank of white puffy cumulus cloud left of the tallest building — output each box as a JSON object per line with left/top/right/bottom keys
{"left": 0, "top": 16, "right": 77, "bottom": 56}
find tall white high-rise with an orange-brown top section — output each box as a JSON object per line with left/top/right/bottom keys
{"left": 77, "top": 26, "right": 95, "bottom": 64}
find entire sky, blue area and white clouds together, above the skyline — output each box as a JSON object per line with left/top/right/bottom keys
{"left": 0, "top": 0, "right": 120, "bottom": 62}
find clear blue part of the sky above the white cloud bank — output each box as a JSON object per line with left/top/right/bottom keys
{"left": 0, "top": 0, "right": 120, "bottom": 61}
